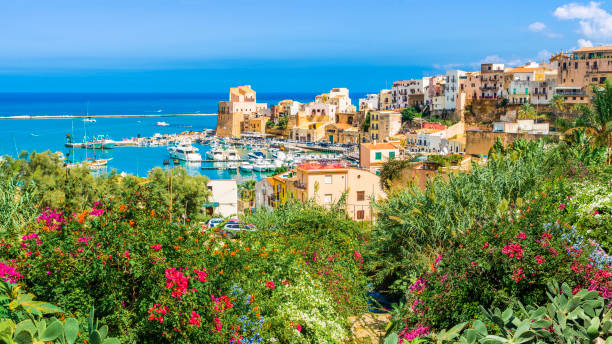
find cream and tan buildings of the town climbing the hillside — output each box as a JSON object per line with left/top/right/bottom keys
{"left": 208, "top": 46, "right": 612, "bottom": 221}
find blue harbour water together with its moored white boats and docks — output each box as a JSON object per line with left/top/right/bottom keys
{"left": 0, "top": 94, "right": 360, "bottom": 182}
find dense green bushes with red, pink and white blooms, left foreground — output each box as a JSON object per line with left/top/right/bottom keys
{"left": 0, "top": 154, "right": 367, "bottom": 343}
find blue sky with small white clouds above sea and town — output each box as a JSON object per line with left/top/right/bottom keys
{"left": 0, "top": 0, "right": 612, "bottom": 92}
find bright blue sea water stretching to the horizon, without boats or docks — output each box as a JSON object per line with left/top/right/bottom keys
{"left": 0, "top": 92, "right": 364, "bottom": 182}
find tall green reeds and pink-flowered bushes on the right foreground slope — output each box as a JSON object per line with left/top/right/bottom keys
{"left": 369, "top": 141, "right": 612, "bottom": 342}
